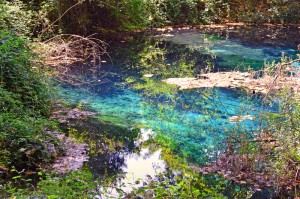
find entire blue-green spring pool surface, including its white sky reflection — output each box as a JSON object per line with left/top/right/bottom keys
{"left": 61, "top": 27, "right": 300, "bottom": 197}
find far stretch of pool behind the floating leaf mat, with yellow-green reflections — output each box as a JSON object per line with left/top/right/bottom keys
{"left": 105, "top": 27, "right": 300, "bottom": 78}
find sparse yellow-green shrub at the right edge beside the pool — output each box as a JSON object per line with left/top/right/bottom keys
{"left": 266, "top": 89, "right": 300, "bottom": 180}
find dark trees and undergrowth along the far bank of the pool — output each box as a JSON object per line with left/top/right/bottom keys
{"left": 0, "top": 0, "right": 300, "bottom": 35}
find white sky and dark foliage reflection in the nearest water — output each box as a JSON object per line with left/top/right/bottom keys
{"left": 69, "top": 122, "right": 172, "bottom": 198}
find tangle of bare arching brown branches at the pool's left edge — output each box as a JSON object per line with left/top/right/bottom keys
{"left": 42, "top": 34, "right": 111, "bottom": 86}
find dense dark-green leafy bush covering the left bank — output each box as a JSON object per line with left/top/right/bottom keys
{"left": 0, "top": 33, "right": 58, "bottom": 176}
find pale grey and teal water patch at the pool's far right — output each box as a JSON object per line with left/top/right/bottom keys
{"left": 158, "top": 30, "right": 299, "bottom": 71}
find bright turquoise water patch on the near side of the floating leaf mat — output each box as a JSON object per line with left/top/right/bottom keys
{"left": 61, "top": 83, "right": 260, "bottom": 163}
